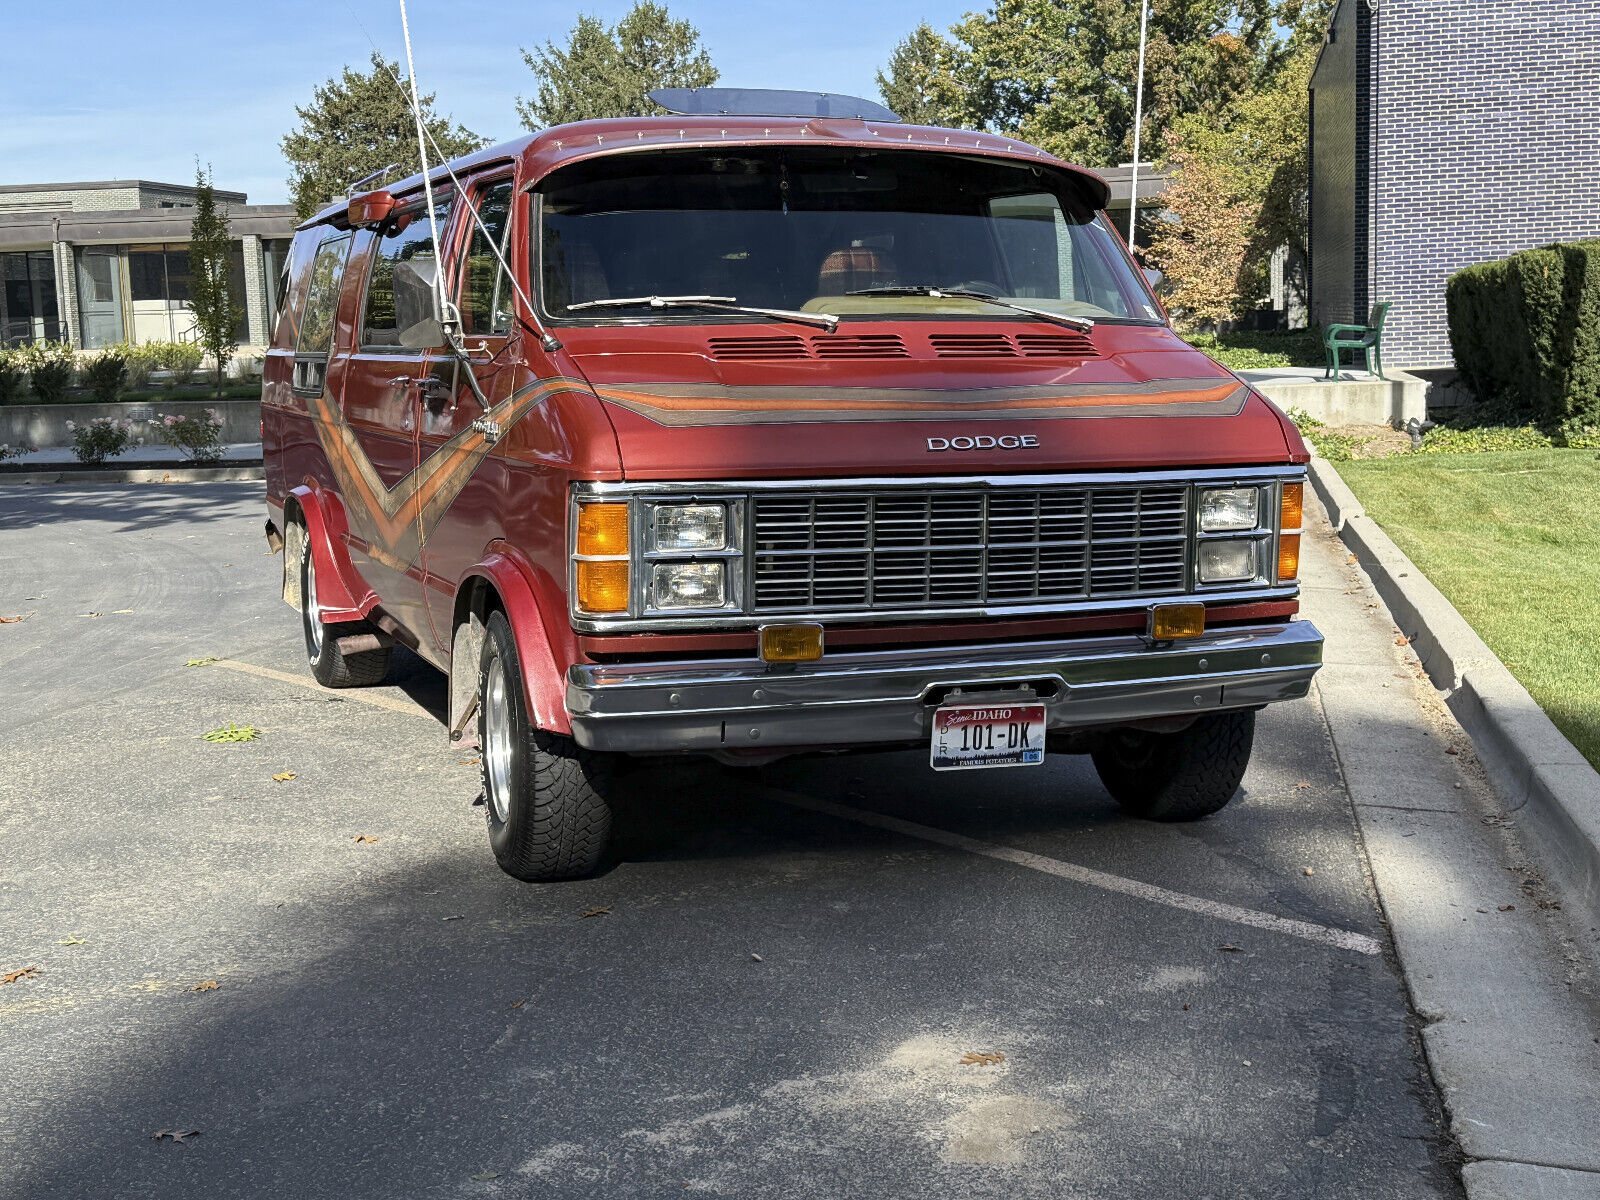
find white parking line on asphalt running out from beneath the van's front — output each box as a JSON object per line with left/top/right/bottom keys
{"left": 762, "top": 787, "right": 1384, "bottom": 954}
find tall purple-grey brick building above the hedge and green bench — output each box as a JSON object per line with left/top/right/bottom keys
{"left": 1310, "top": 0, "right": 1600, "bottom": 368}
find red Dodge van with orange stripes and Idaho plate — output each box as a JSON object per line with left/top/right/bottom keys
{"left": 262, "top": 90, "right": 1322, "bottom": 880}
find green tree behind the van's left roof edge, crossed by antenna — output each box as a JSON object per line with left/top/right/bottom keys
{"left": 278, "top": 51, "right": 486, "bottom": 221}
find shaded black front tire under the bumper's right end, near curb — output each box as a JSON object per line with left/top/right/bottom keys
{"left": 1091, "top": 710, "right": 1256, "bottom": 821}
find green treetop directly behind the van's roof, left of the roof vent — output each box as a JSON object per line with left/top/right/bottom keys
{"left": 517, "top": 0, "right": 718, "bottom": 130}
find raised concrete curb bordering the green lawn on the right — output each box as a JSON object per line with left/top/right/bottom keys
{"left": 1310, "top": 458, "right": 1600, "bottom": 923}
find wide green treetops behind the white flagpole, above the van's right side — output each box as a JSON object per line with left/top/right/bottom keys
{"left": 880, "top": 0, "right": 1330, "bottom": 166}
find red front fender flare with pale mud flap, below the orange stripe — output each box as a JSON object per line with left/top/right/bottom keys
{"left": 450, "top": 544, "right": 573, "bottom": 746}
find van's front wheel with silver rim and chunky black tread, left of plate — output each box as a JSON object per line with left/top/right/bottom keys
{"left": 478, "top": 613, "right": 618, "bottom": 883}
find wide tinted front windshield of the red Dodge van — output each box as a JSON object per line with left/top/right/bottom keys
{"left": 536, "top": 146, "right": 1160, "bottom": 323}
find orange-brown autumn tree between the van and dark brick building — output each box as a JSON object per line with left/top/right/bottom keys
{"left": 1150, "top": 43, "right": 1315, "bottom": 325}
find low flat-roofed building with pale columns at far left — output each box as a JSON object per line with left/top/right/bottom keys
{"left": 0, "top": 179, "right": 294, "bottom": 350}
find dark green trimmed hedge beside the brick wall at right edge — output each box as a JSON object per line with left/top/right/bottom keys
{"left": 1445, "top": 242, "right": 1600, "bottom": 427}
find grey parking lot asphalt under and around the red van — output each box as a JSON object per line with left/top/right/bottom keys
{"left": 0, "top": 483, "right": 1461, "bottom": 1200}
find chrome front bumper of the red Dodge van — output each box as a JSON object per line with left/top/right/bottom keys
{"left": 566, "top": 621, "right": 1322, "bottom": 754}
